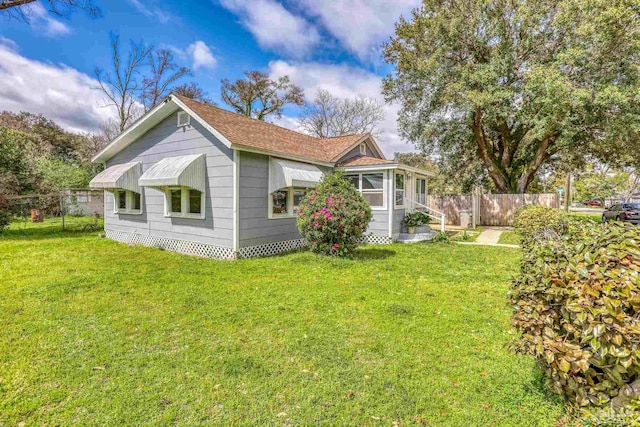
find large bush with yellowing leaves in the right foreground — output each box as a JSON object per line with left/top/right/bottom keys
{"left": 510, "top": 222, "right": 640, "bottom": 407}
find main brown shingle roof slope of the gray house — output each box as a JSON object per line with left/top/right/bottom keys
{"left": 171, "top": 94, "right": 376, "bottom": 162}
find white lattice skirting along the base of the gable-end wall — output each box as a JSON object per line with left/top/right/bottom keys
{"left": 105, "top": 230, "right": 235, "bottom": 259}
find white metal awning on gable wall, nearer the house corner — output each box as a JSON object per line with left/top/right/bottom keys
{"left": 139, "top": 154, "right": 207, "bottom": 193}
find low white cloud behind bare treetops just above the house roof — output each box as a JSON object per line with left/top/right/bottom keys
{"left": 269, "top": 60, "right": 415, "bottom": 158}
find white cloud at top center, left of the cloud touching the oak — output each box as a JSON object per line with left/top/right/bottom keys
{"left": 221, "top": 0, "right": 320, "bottom": 58}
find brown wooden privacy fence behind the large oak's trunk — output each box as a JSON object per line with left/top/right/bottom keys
{"left": 427, "top": 194, "right": 560, "bottom": 226}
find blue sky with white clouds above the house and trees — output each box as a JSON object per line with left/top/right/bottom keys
{"left": 0, "top": 0, "right": 418, "bottom": 155}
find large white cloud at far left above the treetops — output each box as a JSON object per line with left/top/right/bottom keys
{"left": 0, "top": 43, "right": 116, "bottom": 132}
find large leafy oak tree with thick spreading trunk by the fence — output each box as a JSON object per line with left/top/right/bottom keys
{"left": 384, "top": 0, "right": 640, "bottom": 193}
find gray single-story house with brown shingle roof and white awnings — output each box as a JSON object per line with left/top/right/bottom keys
{"left": 90, "top": 94, "right": 432, "bottom": 259}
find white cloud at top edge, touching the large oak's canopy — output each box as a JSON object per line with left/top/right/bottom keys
{"left": 301, "top": 0, "right": 421, "bottom": 59}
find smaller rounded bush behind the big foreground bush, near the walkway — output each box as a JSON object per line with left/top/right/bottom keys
{"left": 513, "top": 205, "right": 569, "bottom": 246}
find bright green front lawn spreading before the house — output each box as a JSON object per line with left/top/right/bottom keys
{"left": 0, "top": 219, "right": 565, "bottom": 426}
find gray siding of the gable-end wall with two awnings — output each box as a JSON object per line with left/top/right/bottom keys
{"left": 105, "top": 113, "right": 233, "bottom": 247}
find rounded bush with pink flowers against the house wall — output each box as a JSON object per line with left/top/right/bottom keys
{"left": 298, "top": 173, "right": 371, "bottom": 256}
